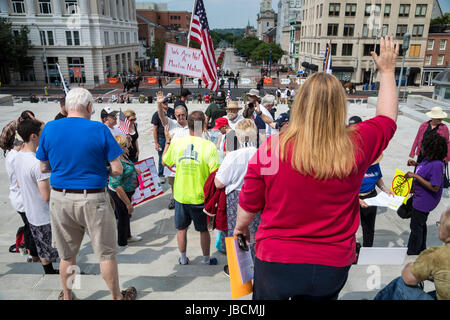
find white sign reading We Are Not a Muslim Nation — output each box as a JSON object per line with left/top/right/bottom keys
{"left": 163, "top": 42, "right": 203, "bottom": 78}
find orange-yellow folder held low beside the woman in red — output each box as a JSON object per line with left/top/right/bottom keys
{"left": 225, "top": 237, "right": 253, "bottom": 299}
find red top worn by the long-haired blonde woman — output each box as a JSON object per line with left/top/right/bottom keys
{"left": 239, "top": 116, "right": 397, "bottom": 267}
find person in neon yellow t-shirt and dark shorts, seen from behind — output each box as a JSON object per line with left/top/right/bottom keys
{"left": 162, "top": 111, "right": 219, "bottom": 264}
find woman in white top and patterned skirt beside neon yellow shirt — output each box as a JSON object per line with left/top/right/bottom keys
{"left": 214, "top": 119, "right": 261, "bottom": 274}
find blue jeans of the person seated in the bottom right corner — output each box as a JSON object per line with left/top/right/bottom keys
{"left": 374, "top": 277, "right": 436, "bottom": 300}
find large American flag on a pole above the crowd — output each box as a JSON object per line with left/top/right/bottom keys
{"left": 189, "top": 0, "right": 219, "bottom": 91}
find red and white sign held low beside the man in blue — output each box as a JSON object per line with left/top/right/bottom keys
{"left": 131, "top": 157, "right": 164, "bottom": 207}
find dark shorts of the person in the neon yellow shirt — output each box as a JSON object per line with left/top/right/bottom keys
{"left": 175, "top": 200, "right": 208, "bottom": 232}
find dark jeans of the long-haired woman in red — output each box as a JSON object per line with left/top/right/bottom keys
{"left": 253, "top": 258, "right": 350, "bottom": 300}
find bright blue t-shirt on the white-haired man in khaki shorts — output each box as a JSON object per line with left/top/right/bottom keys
{"left": 36, "top": 117, "right": 123, "bottom": 189}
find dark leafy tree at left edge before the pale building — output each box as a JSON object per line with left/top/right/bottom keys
{"left": 0, "top": 18, "right": 33, "bottom": 83}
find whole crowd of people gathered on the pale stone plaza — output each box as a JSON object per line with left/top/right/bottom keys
{"left": 0, "top": 38, "right": 450, "bottom": 300}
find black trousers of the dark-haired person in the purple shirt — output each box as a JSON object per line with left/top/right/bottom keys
{"left": 407, "top": 208, "right": 429, "bottom": 255}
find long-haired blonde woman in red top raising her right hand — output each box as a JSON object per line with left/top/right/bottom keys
{"left": 234, "top": 38, "right": 398, "bottom": 300}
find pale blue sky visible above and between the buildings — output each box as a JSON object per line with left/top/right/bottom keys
{"left": 136, "top": 0, "right": 450, "bottom": 29}
